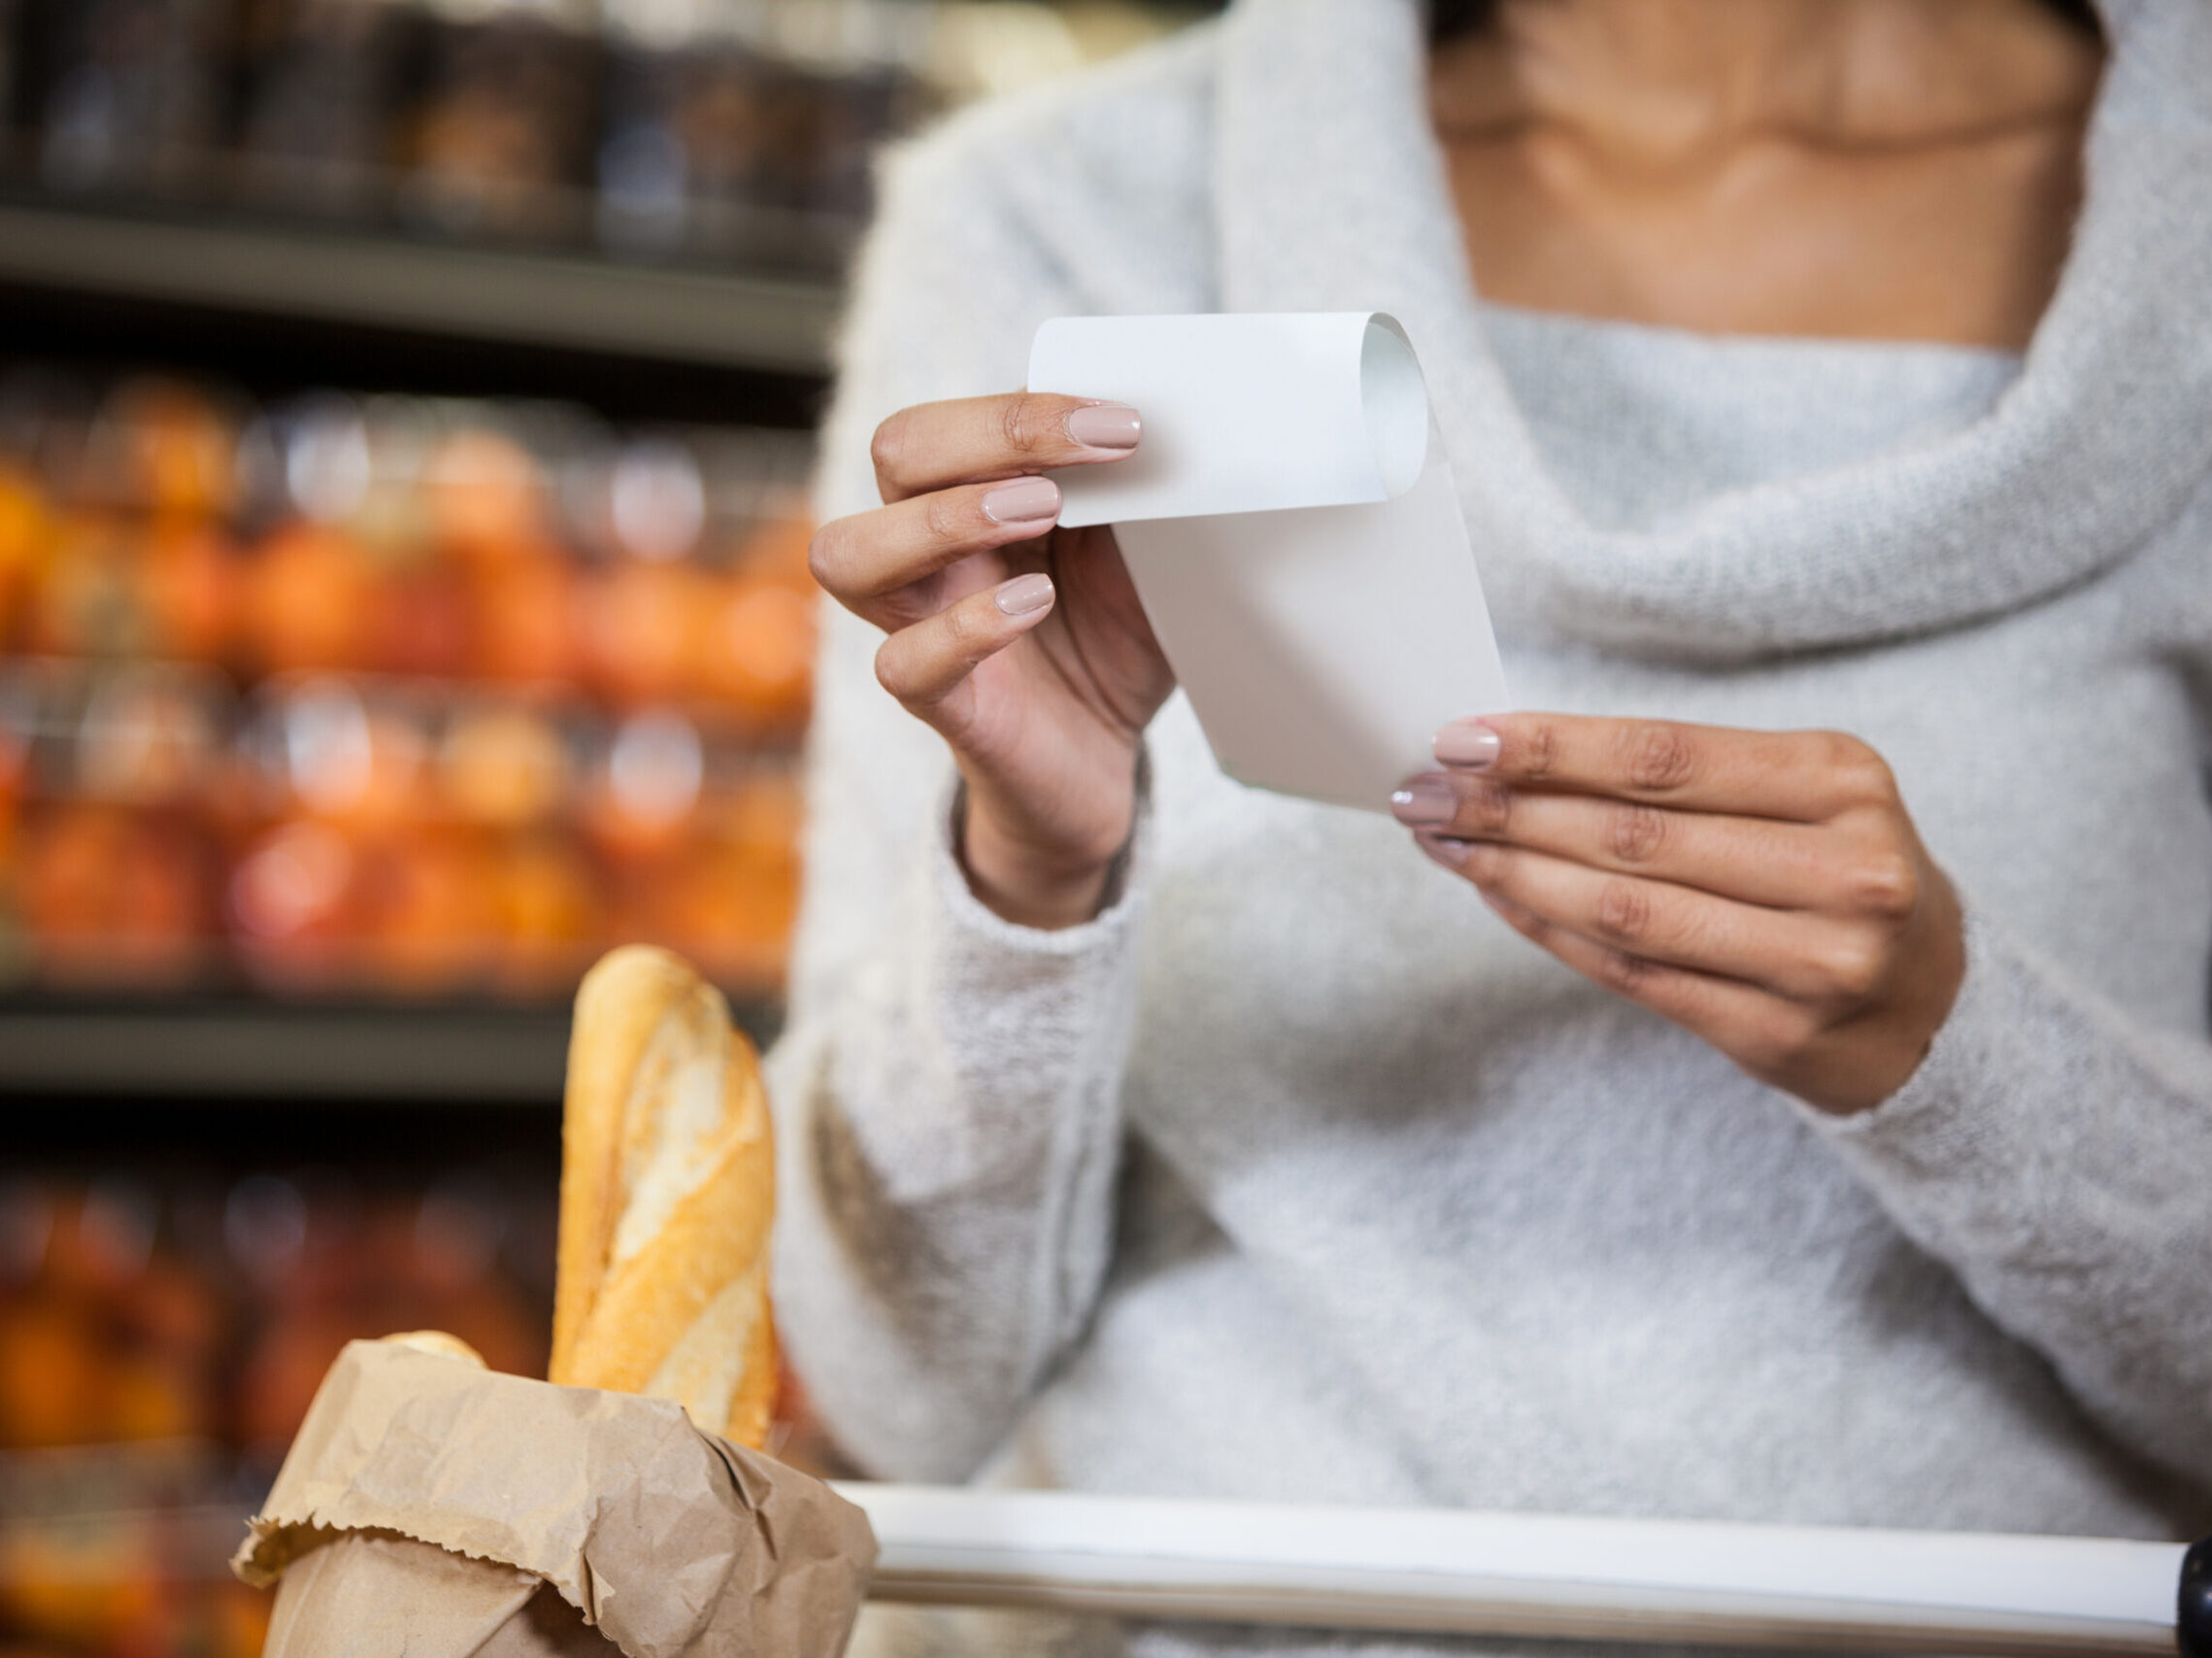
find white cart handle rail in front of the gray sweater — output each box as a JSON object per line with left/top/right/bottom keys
{"left": 838, "top": 1483, "right": 2212, "bottom": 1658}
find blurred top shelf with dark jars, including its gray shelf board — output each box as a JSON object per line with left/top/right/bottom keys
{"left": 0, "top": 0, "right": 1212, "bottom": 374}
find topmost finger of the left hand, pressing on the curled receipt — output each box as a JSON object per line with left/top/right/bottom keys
{"left": 869, "top": 391, "right": 1144, "bottom": 502}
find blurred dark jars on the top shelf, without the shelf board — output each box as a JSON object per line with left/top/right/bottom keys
{"left": 0, "top": 0, "right": 1203, "bottom": 272}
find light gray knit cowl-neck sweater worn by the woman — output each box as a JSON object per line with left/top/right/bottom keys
{"left": 772, "top": 0, "right": 2212, "bottom": 1644}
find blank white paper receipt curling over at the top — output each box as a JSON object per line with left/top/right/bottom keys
{"left": 1028, "top": 312, "right": 1506, "bottom": 812}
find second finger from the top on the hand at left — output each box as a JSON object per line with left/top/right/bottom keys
{"left": 807, "top": 478, "right": 1059, "bottom": 631}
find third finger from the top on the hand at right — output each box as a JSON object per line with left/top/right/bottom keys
{"left": 1429, "top": 836, "right": 1887, "bottom": 1005}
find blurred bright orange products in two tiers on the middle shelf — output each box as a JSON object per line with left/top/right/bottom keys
{"left": 0, "top": 370, "right": 814, "bottom": 1002}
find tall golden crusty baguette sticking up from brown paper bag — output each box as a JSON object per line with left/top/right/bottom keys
{"left": 551, "top": 945, "right": 777, "bottom": 1445}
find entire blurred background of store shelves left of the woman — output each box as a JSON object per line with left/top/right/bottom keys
{"left": 0, "top": 0, "right": 1208, "bottom": 1658}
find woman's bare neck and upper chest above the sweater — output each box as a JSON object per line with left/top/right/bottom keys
{"left": 1431, "top": 0, "right": 2103, "bottom": 346}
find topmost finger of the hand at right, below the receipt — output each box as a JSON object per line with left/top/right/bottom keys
{"left": 1435, "top": 713, "right": 1895, "bottom": 824}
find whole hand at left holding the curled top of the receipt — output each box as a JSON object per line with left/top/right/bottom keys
{"left": 810, "top": 391, "right": 1175, "bottom": 928}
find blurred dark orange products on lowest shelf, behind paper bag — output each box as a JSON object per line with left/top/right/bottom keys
{"left": 0, "top": 1158, "right": 553, "bottom": 1658}
